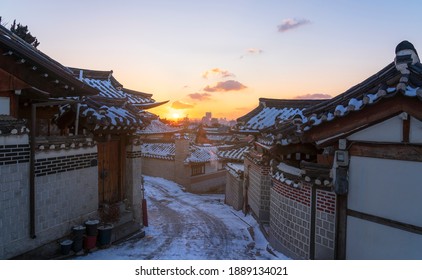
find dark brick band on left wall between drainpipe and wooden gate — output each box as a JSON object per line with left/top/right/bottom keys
{"left": 35, "top": 153, "right": 98, "bottom": 177}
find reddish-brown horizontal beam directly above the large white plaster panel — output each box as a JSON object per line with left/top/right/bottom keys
{"left": 349, "top": 143, "right": 422, "bottom": 162}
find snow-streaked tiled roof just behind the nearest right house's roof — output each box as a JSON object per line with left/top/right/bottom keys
{"left": 237, "top": 98, "right": 322, "bottom": 132}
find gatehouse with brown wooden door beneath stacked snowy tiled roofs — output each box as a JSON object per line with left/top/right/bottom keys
{"left": 57, "top": 68, "right": 165, "bottom": 238}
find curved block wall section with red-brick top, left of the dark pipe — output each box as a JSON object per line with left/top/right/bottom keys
{"left": 270, "top": 180, "right": 311, "bottom": 259}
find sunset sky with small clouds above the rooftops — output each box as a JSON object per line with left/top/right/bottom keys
{"left": 0, "top": 0, "right": 422, "bottom": 119}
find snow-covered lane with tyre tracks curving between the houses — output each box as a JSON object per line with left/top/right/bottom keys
{"left": 78, "top": 176, "right": 288, "bottom": 260}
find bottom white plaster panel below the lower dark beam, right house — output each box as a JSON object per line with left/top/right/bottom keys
{"left": 346, "top": 217, "right": 422, "bottom": 260}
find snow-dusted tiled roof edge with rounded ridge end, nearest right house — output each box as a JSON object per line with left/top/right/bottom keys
{"left": 282, "top": 41, "right": 422, "bottom": 140}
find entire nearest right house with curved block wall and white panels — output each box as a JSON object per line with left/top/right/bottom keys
{"left": 270, "top": 41, "right": 422, "bottom": 259}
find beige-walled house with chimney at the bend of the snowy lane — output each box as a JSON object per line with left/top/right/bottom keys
{"left": 141, "top": 133, "right": 226, "bottom": 193}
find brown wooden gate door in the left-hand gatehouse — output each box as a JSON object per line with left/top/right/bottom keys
{"left": 97, "top": 141, "right": 124, "bottom": 205}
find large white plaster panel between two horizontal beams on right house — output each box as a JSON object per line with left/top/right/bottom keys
{"left": 348, "top": 157, "right": 422, "bottom": 226}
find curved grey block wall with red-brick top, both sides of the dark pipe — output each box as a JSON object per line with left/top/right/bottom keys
{"left": 270, "top": 179, "right": 336, "bottom": 259}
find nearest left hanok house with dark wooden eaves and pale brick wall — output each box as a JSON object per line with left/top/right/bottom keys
{"left": 0, "top": 26, "right": 98, "bottom": 259}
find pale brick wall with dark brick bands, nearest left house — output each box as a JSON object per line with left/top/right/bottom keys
{"left": 0, "top": 136, "right": 98, "bottom": 259}
